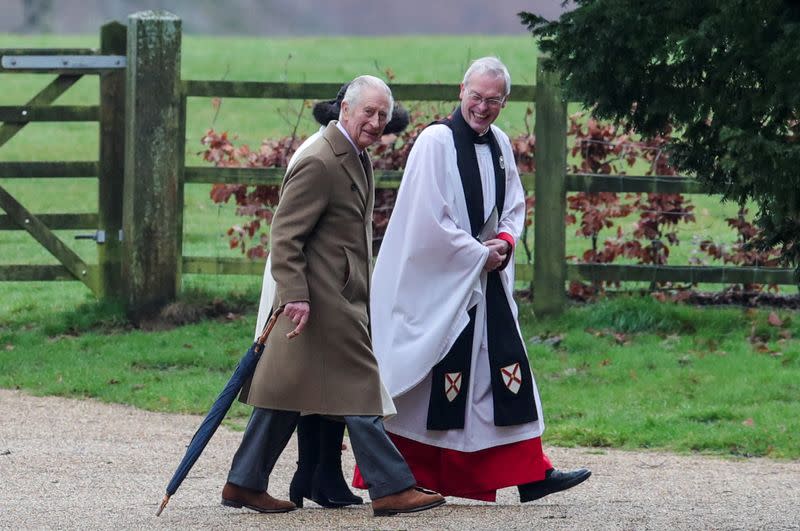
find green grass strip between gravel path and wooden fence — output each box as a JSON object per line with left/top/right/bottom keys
{"left": 0, "top": 277, "right": 800, "bottom": 459}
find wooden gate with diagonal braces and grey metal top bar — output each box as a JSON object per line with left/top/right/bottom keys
{"left": 0, "top": 23, "right": 127, "bottom": 298}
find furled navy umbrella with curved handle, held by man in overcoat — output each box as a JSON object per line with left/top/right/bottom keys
{"left": 156, "top": 308, "right": 283, "bottom": 516}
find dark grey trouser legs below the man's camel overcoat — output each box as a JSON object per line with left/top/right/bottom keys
{"left": 223, "top": 408, "right": 417, "bottom": 500}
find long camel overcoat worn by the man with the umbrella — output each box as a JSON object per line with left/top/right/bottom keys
{"left": 241, "top": 122, "right": 384, "bottom": 415}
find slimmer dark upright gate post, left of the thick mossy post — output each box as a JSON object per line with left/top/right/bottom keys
{"left": 97, "top": 22, "right": 127, "bottom": 299}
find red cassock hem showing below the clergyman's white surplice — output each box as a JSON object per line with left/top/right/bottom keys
{"left": 353, "top": 433, "right": 553, "bottom": 501}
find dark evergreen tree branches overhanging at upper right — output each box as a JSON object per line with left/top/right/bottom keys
{"left": 519, "top": 0, "right": 800, "bottom": 267}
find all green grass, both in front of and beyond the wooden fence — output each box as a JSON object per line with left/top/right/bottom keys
{"left": 0, "top": 35, "right": 800, "bottom": 459}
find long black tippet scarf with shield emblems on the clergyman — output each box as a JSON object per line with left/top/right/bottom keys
{"left": 427, "top": 107, "right": 539, "bottom": 430}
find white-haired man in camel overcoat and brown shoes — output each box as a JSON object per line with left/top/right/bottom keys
{"left": 222, "top": 76, "right": 444, "bottom": 516}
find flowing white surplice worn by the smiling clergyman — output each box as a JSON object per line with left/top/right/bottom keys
{"left": 370, "top": 124, "right": 544, "bottom": 452}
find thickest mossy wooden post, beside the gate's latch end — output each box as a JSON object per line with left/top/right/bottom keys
{"left": 122, "top": 11, "right": 184, "bottom": 319}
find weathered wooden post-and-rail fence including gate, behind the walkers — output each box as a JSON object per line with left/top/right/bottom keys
{"left": 0, "top": 12, "right": 796, "bottom": 315}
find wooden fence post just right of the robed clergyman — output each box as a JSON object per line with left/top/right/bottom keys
{"left": 533, "top": 57, "right": 567, "bottom": 317}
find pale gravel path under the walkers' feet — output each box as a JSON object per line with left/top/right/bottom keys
{"left": 0, "top": 390, "right": 800, "bottom": 531}
